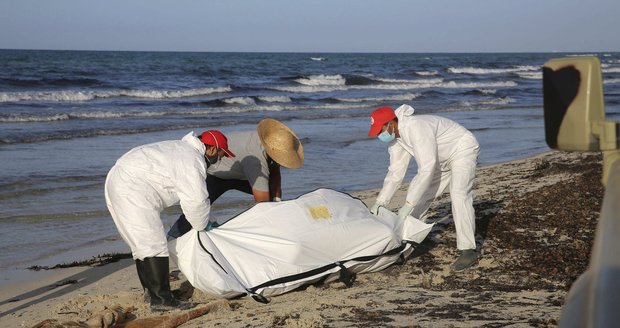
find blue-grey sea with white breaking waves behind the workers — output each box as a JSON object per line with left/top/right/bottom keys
{"left": 0, "top": 50, "right": 620, "bottom": 283}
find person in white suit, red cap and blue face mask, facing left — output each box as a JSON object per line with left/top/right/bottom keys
{"left": 368, "top": 105, "right": 480, "bottom": 271}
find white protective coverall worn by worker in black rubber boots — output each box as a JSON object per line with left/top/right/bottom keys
{"left": 105, "top": 132, "right": 211, "bottom": 260}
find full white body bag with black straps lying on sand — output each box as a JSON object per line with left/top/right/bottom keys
{"left": 169, "top": 189, "right": 433, "bottom": 302}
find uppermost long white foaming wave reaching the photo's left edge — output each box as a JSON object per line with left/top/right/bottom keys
{"left": 0, "top": 86, "right": 232, "bottom": 102}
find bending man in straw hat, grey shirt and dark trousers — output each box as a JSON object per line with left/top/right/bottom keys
{"left": 168, "top": 118, "right": 304, "bottom": 238}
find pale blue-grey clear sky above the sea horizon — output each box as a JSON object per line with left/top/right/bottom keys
{"left": 0, "top": 0, "right": 620, "bottom": 52}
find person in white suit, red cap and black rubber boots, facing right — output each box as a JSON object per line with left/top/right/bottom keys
{"left": 105, "top": 130, "right": 235, "bottom": 311}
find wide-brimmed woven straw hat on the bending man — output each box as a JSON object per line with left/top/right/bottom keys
{"left": 256, "top": 118, "right": 304, "bottom": 169}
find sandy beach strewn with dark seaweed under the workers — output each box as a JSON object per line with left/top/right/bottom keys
{"left": 0, "top": 152, "right": 603, "bottom": 328}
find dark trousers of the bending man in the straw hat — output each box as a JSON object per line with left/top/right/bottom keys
{"left": 168, "top": 174, "right": 252, "bottom": 238}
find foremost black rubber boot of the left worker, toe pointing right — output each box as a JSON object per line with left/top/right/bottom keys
{"left": 144, "top": 257, "right": 194, "bottom": 311}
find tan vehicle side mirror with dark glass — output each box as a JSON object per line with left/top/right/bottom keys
{"left": 543, "top": 56, "right": 617, "bottom": 151}
